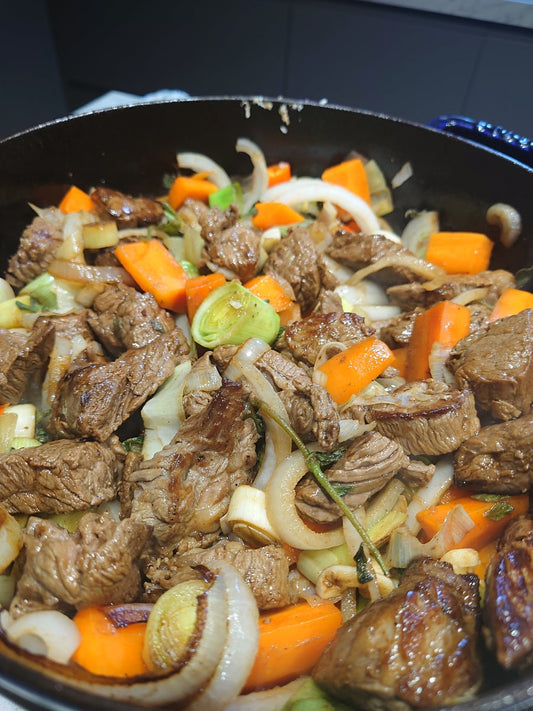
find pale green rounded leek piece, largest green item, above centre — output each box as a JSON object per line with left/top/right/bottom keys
{"left": 191, "top": 281, "right": 280, "bottom": 348}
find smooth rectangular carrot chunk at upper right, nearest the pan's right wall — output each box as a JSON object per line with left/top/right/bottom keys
{"left": 426, "top": 232, "right": 494, "bottom": 274}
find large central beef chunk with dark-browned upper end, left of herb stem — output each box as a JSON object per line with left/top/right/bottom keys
{"left": 130, "top": 381, "right": 258, "bottom": 550}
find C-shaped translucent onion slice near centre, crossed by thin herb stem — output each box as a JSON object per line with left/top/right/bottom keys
{"left": 265, "top": 451, "right": 344, "bottom": 550}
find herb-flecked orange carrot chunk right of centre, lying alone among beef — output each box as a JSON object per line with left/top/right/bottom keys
{"left": 318, "top": 336, "right": 394, "bottom": 405}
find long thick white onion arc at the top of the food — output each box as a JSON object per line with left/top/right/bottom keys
{"left": 260, "top": 178, "right": 381, "bottom": 234}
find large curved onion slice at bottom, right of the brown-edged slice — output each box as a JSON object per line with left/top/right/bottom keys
{"left": 187, "top": 561, "right": 259, "bottom": 711}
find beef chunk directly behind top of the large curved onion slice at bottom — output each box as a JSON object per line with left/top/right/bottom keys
{"left": 146, "top": 539, "right": 297, "bottom": 610}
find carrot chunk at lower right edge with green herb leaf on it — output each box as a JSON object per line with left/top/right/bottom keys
{"left": 416, "top": 494, "right": 529, "bottom": 550}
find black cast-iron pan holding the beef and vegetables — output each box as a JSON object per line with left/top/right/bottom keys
{"left": 0, "top": 97, "right": 533, "bottom": 711}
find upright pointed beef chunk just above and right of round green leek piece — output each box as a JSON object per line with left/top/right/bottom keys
{"left": 263, "top": 225, "right": 337, "bottom": 316}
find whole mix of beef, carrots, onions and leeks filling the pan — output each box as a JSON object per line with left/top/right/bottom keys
{"left": 0, "top": 97, "right": 533, "bottom": 709}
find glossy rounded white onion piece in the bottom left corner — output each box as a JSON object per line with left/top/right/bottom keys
{"left": 2, "top": 610, "right": 81, "bottom": 664}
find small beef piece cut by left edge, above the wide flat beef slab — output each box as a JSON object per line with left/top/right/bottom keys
{"left": 0, "top": 319, "right": 54, "bottom": 405}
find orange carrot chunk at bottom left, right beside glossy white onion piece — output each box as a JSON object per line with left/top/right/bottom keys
{"left": 72, "top": 605, "right": 148, "bottom": 677}
